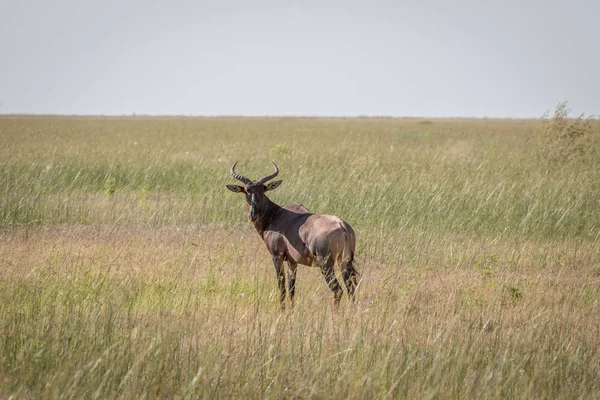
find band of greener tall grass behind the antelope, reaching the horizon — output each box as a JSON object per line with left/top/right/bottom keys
{"left": 0, "top": 117, "right": 600, "bottom": 238}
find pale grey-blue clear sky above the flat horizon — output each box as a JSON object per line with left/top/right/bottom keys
{"left": 0, "top": 0, "right": 600, "bottom": 118}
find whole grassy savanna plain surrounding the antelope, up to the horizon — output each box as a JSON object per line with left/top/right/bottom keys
{"left": 0, "top": 115, "right": 600, "bottom": 399}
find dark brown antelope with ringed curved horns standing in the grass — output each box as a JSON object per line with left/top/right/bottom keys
{"left": 226, "top": 161, "right": 358, "bottom": 310}
